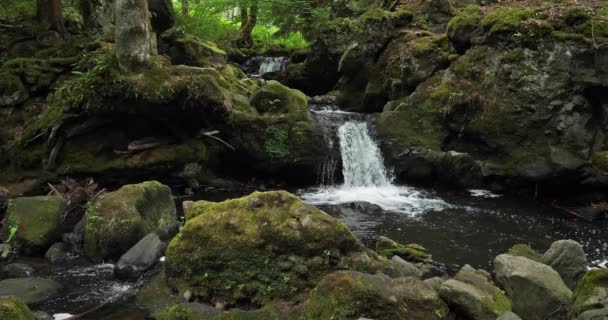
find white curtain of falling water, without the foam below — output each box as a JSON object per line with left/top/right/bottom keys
{"left": 338, "top": 121, "right": 391, "bottom": 188}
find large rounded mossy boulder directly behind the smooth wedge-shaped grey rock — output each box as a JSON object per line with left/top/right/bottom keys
{"left": 84, "top": 181, "right": 176, "bottom": 260}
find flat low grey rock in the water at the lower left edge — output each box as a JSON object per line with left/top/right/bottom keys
{"left": 0, "top": 278, "right": 63, "bottom": 304}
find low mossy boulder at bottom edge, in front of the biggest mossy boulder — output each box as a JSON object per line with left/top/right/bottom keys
{"left": 303, "top": 271, "right": 449, "bottom": 320}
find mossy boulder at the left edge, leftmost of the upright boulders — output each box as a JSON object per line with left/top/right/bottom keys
{"left": 0, "top": 197, "right": 67, "bottom": 254}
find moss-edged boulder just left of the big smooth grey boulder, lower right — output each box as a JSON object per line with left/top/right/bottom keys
{"left": 439, "top": 266, "right": 511, "bottom": 320}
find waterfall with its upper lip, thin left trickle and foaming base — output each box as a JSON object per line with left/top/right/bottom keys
{"left": 300, "top": 97, "right": 450, "bottom": 214}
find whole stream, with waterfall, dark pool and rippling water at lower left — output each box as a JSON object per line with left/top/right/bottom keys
{"left": 26, "top": 97, "right": 608, "bottom": 320}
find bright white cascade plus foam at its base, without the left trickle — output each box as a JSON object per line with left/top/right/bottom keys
{"left": 300, "top": 121, "right": 450, "bottom": 215}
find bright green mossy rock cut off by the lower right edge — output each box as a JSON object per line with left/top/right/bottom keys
{"left": 573, "top": 269, "right": 608, "bottom": 312}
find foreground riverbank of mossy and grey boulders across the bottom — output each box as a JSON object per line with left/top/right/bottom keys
{"left": 0, "top": 182, "right": 608, "bottom": 320}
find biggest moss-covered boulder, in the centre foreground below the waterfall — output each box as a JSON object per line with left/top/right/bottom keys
{"left": 165, "top": 191, "right": 364, "bottom": 304}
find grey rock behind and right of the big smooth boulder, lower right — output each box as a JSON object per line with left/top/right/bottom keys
{"left": 542, "top": 240, "right": 587, "bottom": 290}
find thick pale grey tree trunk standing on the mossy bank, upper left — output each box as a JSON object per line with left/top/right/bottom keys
{"left": 114, "top": 0, "right": 150, "bottom": 73}
